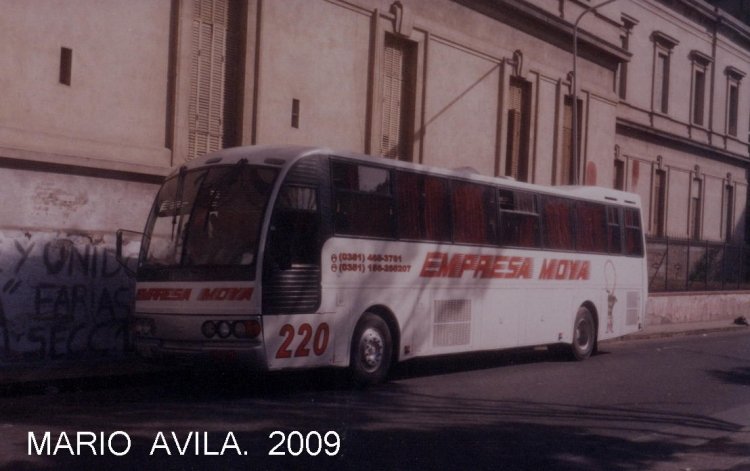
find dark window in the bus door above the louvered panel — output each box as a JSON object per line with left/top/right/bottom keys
{"left": 269, "top": 185, "right": 320, "bottom": 270}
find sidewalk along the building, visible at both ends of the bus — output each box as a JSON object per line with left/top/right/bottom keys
{"left": 0, "top": 319, "right": 750, "bottom": 393}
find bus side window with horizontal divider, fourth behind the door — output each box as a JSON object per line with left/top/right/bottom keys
{"left": 498, "top": 188, "right": 539, "bottom": 247}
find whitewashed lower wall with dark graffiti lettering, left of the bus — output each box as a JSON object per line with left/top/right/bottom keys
{"left": 0, "top": 232, "right": 133, "bottom": 365}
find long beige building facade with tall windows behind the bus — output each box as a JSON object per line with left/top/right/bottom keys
{"left": 0, "top": 0, "right": 750, "bottom": 365}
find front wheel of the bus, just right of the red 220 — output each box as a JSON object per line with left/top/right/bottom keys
{"left": 350, "top": 312, "right": 393, "bottom": 386}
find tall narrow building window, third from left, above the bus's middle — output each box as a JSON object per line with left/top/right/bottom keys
{"left": 505, "top": 77, "right": 531, "bottom": 182}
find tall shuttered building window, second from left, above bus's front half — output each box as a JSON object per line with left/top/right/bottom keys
{"left": 380, "top": 33, "right": 417, "bottom": 161}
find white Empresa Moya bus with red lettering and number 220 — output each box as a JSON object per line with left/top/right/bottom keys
{"left": 117, "top": 146, "right": 647, "bottom": 384}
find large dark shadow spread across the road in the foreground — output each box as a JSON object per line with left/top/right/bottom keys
{"left": 0, "top": 370, "right": 746, "bottom": 471}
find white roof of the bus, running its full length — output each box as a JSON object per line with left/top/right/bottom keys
{"left": 175, "top": 145, "right": 640, "bottom": 206}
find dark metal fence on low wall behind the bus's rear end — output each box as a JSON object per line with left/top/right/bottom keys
{"left": 646, "top": 239, "right": 750, "bottom": 292}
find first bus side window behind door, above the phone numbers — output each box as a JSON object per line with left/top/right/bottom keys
{"left": 331, "top": 162, "right": 394, "bottom": 238}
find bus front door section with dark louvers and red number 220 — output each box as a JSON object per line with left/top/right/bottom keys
{"left": 262, "top": 158, "right": 333, "bottom": 369}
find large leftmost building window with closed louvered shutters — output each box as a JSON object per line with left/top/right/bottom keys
{"left": 188, "top": 0, "right": 243, "bottom": 159}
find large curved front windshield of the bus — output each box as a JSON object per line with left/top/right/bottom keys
{"left": 140, "top": 163, "right": 278, "bottom": 278}
